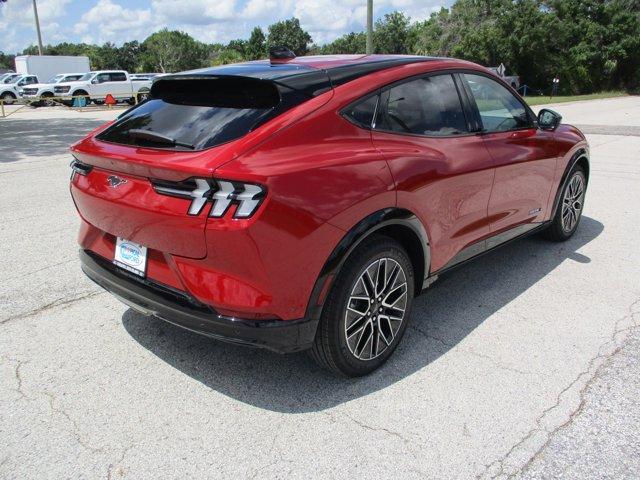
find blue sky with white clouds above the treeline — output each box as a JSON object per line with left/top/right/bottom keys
{"left": 0, "top": 0, "right": 452, "bottom": 53}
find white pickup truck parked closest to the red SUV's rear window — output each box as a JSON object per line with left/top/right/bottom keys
{"left": 53, "top": 70, "right": 151, "bottom": 105}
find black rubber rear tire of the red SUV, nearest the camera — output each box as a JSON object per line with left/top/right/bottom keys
{"left": 309, "top": 235, "right": 415, "bottom": 377}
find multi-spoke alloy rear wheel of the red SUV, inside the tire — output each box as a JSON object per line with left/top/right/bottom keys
{"left": 344, "top": 258, "right": 407, "bottom": 360}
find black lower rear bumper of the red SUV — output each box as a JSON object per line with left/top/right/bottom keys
{"left": 80, "top": 250, "right": 317, "bottom": 353}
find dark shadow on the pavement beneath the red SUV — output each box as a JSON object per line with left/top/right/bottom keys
{"left": 122, "top": 217, "right": 604, "bottom": 413}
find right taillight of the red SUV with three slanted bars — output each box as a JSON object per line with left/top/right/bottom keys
{"left": 151, "top": 178, "right": 265, "bottom": 218}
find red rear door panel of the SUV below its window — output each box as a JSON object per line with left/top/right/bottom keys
{"left": 373, "top": 131, "right": 494, "bottom": 272}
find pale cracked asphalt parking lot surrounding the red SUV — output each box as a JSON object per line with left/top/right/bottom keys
{"left": 0, "top": 97, "right": 640, "bottom": 479}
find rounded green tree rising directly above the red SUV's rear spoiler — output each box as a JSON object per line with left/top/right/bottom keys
{"left": 140, "top": 28, "right": 208, "bottom": 73}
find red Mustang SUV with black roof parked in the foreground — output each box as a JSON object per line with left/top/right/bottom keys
{"left": 71, "top": 51, "right": 589, "bottom": 376}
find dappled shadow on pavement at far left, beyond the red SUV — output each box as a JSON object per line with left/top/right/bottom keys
{"left": 0, "top": 113, "right": 106, "bottom": 163}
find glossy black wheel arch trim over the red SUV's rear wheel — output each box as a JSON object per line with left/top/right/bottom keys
{"left": 306, "top": 208, "right": 431, "bottom": 319}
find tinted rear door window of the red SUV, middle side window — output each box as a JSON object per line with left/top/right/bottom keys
{"left": 376, "top": 75, "right": 467, "bottom": 136}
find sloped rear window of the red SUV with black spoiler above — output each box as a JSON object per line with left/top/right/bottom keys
{"left": 98, "top": 77, "right": 282, "bottom": 150}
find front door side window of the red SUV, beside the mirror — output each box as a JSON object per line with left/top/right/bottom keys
{"left": 464, "top": 74, "right": 532, "bottom": 132}
